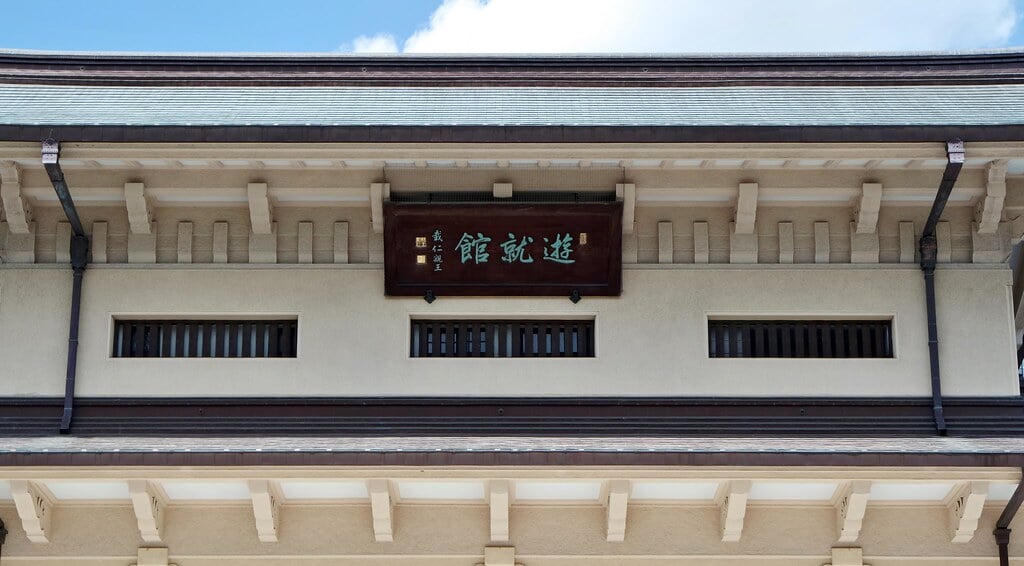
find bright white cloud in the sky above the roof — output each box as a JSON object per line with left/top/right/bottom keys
{"left": 395, "top": 0, "right": 1020, "bottom": 53}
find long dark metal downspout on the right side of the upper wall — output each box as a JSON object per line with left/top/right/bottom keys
{"left": 919, "top": 139, "right": 964, "bottom": 436}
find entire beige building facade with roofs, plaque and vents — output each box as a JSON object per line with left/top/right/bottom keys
{"left": 0, "top": 52, "right": 1024, "bottom": 566}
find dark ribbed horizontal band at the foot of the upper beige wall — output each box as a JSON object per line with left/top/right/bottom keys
{"left": 0, "top": 397, "right": 1024, "bottom": 437}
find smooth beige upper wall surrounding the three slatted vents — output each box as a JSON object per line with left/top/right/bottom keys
{"left": 0, "top": 265, "right": 1018, "bottom": 396}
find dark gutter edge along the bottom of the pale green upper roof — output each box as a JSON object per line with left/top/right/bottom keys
{"left": 0, "top": 124, "right": 1024, "bottom": 143}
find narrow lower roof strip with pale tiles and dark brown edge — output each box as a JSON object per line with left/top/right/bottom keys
{"left": 0, "top": 435, "right": 1024, "bottom": 468}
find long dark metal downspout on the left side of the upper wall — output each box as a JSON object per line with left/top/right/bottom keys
{"left": 43, "top": 139, "right": 89, "bottom": 434}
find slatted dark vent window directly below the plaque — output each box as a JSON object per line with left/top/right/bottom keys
{"left": 409, "top": 320, "right": 594, "bottom": 357}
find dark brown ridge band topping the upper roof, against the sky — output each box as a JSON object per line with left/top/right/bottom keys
{"left": 6, "top": 51, "right": 1024, "bottom": 87}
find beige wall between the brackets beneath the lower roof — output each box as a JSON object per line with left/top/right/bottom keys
{"left": 0, "top": 505, "right": 1024, "bottom": 566}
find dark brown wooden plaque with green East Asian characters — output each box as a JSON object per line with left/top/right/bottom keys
{"left": 384, "top": 203, "right": 623, "bottom": 297}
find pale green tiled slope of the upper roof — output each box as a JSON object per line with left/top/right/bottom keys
{"left": 0, "top": 84, "right": 1024, "bottom": 127}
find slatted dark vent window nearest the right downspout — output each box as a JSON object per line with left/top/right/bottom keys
{"left": 708, "top": 320, "right": 893, "bottom": 358}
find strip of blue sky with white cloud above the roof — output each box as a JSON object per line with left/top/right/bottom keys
{"left": 0, "top": 0, "right": 1024, "bottom": 52}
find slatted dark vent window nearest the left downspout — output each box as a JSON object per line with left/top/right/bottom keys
{"left": 113, "top": 319, "right": 298, "bottom": 357}
